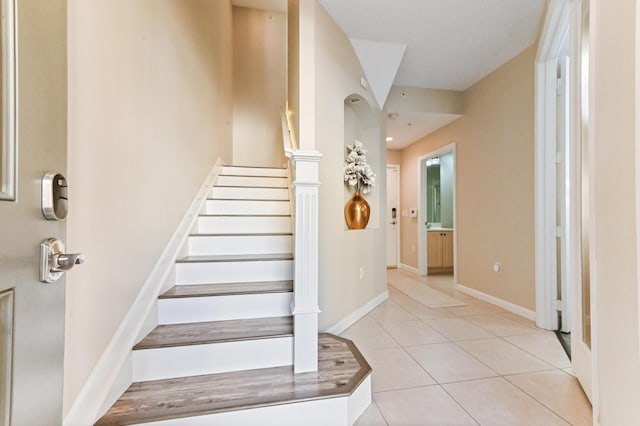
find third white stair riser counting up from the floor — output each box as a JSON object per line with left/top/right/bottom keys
{"left": 158, "top": 293, "right": 293, "bottom": 324}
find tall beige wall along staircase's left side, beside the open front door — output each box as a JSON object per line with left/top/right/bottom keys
{"left": 65, "top": 0, "right": 232, "bottom": 411}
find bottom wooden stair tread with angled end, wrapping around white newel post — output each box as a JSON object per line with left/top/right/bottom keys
{"left": 96, "top": 334, "right": 371, "bottom": 426}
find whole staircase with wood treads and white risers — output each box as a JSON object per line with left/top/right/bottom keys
{"left": 96, "top": 166, "right": 371, "bottom": 425}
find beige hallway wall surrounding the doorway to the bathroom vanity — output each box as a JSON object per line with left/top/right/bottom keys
{"left": 401, "top": 47, "right": 536, "bottom": 310}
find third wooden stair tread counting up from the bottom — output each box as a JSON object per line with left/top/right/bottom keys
{"left": 160, "top": 281, "right": 293, "bottom": 299}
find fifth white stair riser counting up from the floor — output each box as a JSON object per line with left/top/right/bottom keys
{"left": 189, "top": 235, "right": 293, "bottom": 256}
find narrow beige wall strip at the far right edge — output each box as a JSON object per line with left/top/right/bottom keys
{"left": 591, "top": 0, "right": 640, "bottom": 426}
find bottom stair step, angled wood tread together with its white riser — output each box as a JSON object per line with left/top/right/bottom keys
{"left": 96, "top": 334, "right": 371, "bottom": 425}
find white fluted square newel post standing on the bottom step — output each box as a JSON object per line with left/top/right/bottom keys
{"left": 291, "top": 150, "right": 322, "bottom": 373}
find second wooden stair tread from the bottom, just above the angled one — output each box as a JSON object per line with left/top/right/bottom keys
{"left": 133, "top": 316, "right": 293, "bottom": 350}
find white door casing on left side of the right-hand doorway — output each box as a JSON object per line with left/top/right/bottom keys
{"left": 535, "top": 0, "right": 571, "bottom": 330}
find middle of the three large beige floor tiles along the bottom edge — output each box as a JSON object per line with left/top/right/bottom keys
{"left": 443, "top": 377, "right": 568, "bottom": 426}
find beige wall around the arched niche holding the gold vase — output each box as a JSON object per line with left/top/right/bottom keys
{"left": 312, "top": 1, "right": 386, "bottom": 330}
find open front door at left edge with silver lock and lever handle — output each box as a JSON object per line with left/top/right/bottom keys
{"left": 0, "top": 0, "right": 72, "bottom": 426}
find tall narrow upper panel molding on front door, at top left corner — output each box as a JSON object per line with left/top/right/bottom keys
{"left": 0, "top": 0, "right": 17, "bottom": 200}
